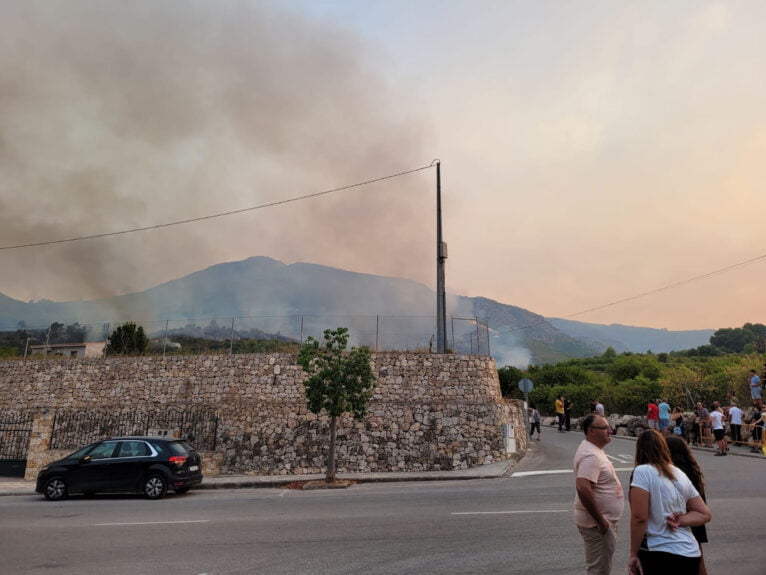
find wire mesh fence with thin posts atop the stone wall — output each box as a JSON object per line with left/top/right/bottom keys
{"left": 2, "top": 314, "right": 490, "bottom": 357}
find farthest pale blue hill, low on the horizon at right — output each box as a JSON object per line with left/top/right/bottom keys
{"left": 548, "top": 318, "right": 715, "bottom": 353}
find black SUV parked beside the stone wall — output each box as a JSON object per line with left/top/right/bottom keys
{"left": 35, "top": 437, "right": 202, "bottom": 501}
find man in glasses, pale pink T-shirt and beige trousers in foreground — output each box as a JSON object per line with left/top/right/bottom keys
{"left": 574, "top": 413, "right": 625, "bottom": 575}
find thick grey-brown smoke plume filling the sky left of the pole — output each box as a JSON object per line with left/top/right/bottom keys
{"left": 0, "top": 0, "right": 434, "bottom": 306}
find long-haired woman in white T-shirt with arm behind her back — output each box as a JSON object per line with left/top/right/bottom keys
{"left": 628, "top": 429, "right": 711, "bottom": 575}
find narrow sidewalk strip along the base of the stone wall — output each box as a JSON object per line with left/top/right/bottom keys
{"left": 0, "top": 459, "right": 517, "bottom": 496}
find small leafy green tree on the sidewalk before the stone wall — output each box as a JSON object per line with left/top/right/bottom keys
{"left": 298, "top": 327, "right": 375, "bottom": 483}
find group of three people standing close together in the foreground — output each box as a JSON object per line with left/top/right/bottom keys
{"left": 574, "top": 413, "right": 712, "bottom": 575}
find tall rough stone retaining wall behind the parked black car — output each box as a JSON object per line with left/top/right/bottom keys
{"left": 0, "top": 353, "right": 526, "bottom": 477}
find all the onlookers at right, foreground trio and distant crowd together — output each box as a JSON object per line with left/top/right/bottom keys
{"left": 568, "top": 364, "right": 766, "bottom": 575}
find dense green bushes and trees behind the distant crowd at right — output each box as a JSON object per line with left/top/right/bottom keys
{"left": 498, "top": 323, "right": 766, "bottom": 417}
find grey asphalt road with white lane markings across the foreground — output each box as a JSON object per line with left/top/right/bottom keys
{"left": 0, "top": 430, "right": 766, "bottom": 575}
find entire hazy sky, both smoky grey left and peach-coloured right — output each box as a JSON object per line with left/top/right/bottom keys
{"left": 0, "top": 0, "right": 766, "bottom": 329}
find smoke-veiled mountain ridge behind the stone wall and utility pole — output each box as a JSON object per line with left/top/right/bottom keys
{"left": 0, "top": 257, "right": 712, "bottom": 366}
